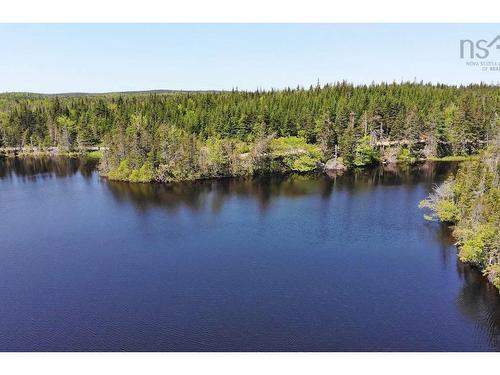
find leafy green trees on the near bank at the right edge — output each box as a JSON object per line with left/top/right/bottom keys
{"left": 420, "top": 137, "right": 500, "bottom": 289}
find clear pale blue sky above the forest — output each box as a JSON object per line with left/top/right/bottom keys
{"left": 0, "top": 24, "right": 500, "bottom": 93}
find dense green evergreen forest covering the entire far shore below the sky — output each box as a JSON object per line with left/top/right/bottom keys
{"left": 0, "top": 82, "right": 500, "bottom": 182}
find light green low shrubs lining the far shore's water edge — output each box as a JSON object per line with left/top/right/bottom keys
{"left": 0, "top": 137, "right": 478, "bottom": 182}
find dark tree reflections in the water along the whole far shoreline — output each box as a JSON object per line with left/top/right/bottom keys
{"left": 0, "top": 156, "right": 457, "bottom": 212}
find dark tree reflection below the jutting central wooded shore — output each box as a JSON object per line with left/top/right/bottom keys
{"left": 106, "top": 162, "right": 457, "bottom": 212}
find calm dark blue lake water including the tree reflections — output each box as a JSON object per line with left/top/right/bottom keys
{"left": 0, "top": 158, "right": 500, "bottom": 351}
